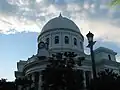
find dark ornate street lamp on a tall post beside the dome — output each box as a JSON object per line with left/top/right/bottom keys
{"left": 86, "top": 31, "right": 96, "bottom": 79}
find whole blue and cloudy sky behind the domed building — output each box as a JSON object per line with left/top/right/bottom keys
{"left": 0, "top": 0, "right": 120, "bottom": 80}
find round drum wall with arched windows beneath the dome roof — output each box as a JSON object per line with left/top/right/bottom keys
{"left": 38, "top": 30, "right": 84, "bottom": 53}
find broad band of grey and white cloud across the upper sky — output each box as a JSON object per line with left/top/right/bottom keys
{"left": 0, "top": 0, "right": 120, "bottom": 43}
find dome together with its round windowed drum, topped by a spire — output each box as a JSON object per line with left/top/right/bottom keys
{"left": 38, "top": 14, "right": 84, "bottom": 54}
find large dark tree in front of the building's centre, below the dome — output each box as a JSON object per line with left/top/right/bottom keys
{"left": 42, "top": 52, "right": 83, "bottom": 90}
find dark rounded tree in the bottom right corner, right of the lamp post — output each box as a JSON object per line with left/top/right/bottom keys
{"left": 89, "top": 69, "right": 120, "bottom": 90}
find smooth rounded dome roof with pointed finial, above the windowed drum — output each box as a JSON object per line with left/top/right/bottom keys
{"left": 41, "top": 14, "right": 80, "bottom": 32}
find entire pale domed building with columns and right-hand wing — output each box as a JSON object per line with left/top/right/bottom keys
{"left": 15, "top": 14, "right": 119, "bottom": 90}
